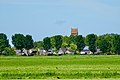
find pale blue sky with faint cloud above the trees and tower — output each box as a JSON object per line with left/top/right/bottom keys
{"left": 0, "top": 0, "right": 120, "bottom": 45}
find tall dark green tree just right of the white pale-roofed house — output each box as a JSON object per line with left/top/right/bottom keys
{"left": 85, "top": 34, "right": 97, "bottom": 53}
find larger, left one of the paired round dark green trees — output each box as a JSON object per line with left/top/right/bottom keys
{"left": 12, "top": 34, "right": 26, "bottom": 50}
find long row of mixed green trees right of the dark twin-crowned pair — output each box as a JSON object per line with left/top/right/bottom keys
{"left": 34, "top": 33, "right": 120, "bottom": 54}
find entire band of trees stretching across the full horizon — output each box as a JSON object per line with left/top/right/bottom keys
{"left": 0, "top": 33, "right": 120, "bottom": 55}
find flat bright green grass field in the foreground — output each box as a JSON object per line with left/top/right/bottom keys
{"left": 0, "top": 55, "right": 120, "bottom": 80}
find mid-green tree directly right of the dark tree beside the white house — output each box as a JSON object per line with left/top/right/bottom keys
{"left": 96, "top": 36, "right": 109, "bottom": 53}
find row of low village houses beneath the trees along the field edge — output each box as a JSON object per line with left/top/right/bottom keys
{"left": 15, "top": 46, "right": 101, "bottom": 56}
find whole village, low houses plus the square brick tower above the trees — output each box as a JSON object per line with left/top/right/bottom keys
{"left": 15, "top": 28, "right": 101, "bottom": 56}
